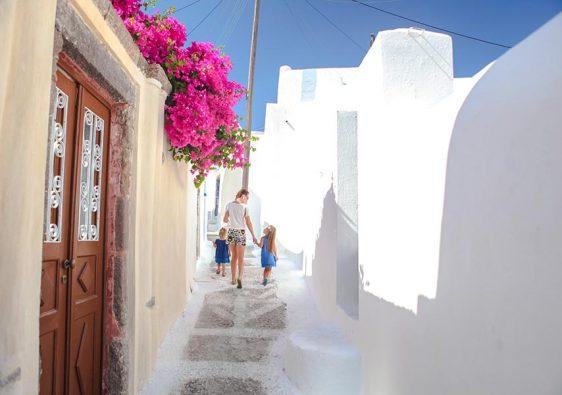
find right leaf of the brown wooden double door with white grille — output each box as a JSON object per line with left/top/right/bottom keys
{"left": 69, "top": 88, "right": 110, "bottom": 394}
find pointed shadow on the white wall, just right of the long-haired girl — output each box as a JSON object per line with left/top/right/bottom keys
{"left": 310, "top": 187, "right": 359, "bottom": 319}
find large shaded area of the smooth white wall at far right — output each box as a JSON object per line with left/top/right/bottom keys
{"left": 359, "top": 15, "right": 562, "bottom": 395}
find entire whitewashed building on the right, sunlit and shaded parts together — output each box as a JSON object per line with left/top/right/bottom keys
{"left": 251, "top": 15, "right": 562, "bottom": 394}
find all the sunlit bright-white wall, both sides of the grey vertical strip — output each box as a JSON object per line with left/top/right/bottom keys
{"left": 254, "top": 29, "right": 468, "bottom": 311}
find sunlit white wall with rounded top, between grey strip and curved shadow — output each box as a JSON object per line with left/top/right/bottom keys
{"left": 358, "top": 29, "right": 480, "bottom": 311}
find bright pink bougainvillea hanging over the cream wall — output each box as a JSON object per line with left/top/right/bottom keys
{"left": 113, "top": 0, "right": 252, "bottom": 185}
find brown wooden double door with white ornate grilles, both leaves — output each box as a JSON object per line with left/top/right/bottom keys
{"left": 39, "top": 68, "right": 110, "bottom": 395}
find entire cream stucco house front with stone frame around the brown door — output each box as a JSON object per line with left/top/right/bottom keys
{"left": 0, "top": 0, "right": 197, "bottom": 394}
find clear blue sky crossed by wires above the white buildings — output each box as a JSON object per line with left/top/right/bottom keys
{"left": 154, "top": 0, "right": 562, "bottom": 130}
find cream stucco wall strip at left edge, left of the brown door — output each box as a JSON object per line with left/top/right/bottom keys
{"left": 0, "top": 0, "right": 56, "bottom": 394}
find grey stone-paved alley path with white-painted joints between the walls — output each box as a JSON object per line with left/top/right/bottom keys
{"left": 142, "top": 252, "right": 318, "bottom": 394}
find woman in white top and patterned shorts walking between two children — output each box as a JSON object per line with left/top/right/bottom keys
{"left": 224, "top": 189, "right": 258, "bottom": 288}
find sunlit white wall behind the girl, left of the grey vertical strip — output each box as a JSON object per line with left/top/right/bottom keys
{"left": 251, "top": 66, "right": 355, "bottom": 262}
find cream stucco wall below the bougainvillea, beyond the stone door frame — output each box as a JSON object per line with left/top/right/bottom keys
{"left": 135, "top": 80, "right": 196, "bottom": 388}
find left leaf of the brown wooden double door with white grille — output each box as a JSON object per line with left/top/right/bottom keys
{"left": 39, "top": 71, "right": 78, "bottom": 394}
